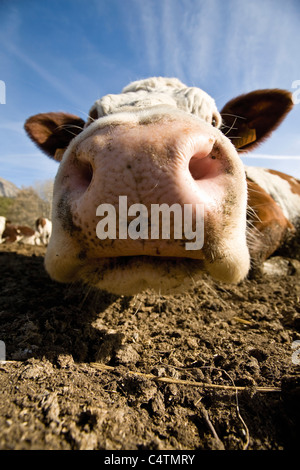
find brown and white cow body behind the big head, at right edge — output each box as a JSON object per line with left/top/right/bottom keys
{"left": 245, "top": 167, "right": 300, "bottom": 264}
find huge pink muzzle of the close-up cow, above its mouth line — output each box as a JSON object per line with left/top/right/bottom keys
{"left": 46, "top": 109, "right": 248, "bottom": 290}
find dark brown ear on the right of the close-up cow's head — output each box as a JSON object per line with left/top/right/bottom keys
{"left": 221, "top": 89, "right": 293, "bottom": 152}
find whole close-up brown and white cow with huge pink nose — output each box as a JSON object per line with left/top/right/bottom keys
{"left": 25, "top": 77, "right": 300, "bottom": 295}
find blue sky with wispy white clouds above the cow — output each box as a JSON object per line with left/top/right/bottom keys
{"left": 0, "top": 0, "right": 300, "bottom": 187}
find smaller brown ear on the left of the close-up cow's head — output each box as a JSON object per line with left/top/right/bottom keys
{"left": 24, "top": 112, "right": 85, "bottom": 161}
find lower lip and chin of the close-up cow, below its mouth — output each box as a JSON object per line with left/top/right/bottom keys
{"left": 45, "top": 223, "right": 250, "bottom": 295}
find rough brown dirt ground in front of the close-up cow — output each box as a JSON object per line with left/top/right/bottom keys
{"left": 0, "top": 245, "right": 300, "bottom": 451}
